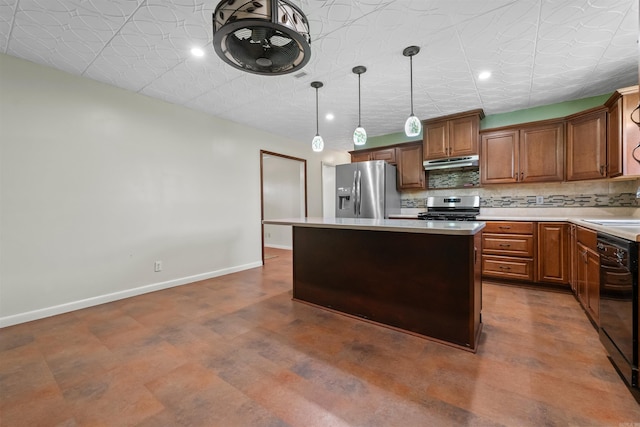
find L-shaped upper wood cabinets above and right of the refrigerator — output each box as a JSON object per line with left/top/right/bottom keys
{"left": 349, "top": 141, "right": 426, "bottom": 190}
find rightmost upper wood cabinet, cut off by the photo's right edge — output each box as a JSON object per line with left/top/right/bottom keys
{"left": 605, "top": 86, "right": 640, "bottom": 177}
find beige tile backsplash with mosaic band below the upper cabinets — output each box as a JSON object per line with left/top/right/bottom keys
{"left": 401, "top": 179, "right": 640, "bottom": 209}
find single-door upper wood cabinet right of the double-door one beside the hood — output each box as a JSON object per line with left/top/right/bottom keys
{"left": 567, "top": 107, "right": 607, "bottom": 181}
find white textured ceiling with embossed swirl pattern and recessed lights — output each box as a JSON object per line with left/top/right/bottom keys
{"left": 0, "top": 0, "right": 638, "bottom": 150}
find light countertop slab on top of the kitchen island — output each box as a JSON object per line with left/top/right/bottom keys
{"left": 262, "top": 217, "right": 485, "bottom": 236}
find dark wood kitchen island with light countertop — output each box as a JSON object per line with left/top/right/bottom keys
{"left": 264, "top": 218, "right": 484, "bottom": 351}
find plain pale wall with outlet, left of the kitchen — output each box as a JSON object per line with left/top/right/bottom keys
{"left": 0, "top": 54, "right": 348, "bottom": 326}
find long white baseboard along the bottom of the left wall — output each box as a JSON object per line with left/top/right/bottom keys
{"left": 0, "top": 261, "right": 262, "bottom": 328}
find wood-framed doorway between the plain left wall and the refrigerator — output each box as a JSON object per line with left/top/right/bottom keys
{"left": 260, "top": 150, "right": 307, "bottom": 265}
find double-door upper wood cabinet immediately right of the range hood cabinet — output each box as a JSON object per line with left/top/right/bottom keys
{"left": 480, "top": 121, "right": 564, "bottom": 184}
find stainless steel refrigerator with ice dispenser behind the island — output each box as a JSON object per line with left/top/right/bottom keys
{"left": 336, "top": 160, "right": 400, "bottom": 219}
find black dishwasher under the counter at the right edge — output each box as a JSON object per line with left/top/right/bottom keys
{"left": 597, "top": 233, "right": 638, "bottom": 399}
